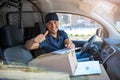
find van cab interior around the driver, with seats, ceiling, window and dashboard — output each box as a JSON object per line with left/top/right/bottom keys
{"left": 0, "top": 0, "right": 120, "bottom": 80}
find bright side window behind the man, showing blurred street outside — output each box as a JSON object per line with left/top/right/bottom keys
{"left": 57, "top": 13, "right": 102, "bottom": 41}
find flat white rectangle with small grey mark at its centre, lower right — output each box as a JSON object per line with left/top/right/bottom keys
{"left": 74, "top": 61, "right": 101, "bottom": 76}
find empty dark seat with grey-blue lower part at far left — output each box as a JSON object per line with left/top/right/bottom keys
{"left": 0, "top": 25, "right": 33, "bottom": 64}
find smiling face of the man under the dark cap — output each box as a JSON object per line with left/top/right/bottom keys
{"left": 46, "top": 20, "right": 58, "bottom": 34}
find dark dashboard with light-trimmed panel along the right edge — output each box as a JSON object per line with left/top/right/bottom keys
{"left": 100, "top": 38, "right": 120, "bottom": 80}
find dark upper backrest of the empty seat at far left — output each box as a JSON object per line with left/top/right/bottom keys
{"left": 0, "top": 25, "right": 24, "bottom": 47}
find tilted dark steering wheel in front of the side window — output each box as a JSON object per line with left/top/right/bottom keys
{"left": 80, "top": 35, "right": 96, "bottom": 55}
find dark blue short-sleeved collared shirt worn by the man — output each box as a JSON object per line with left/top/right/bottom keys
{"left": 40, "top": 30, "right": 68, "bottom": 52}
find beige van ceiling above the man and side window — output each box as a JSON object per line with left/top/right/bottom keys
{"left": 31, "top": 0, "right": 120, "bottom": 24}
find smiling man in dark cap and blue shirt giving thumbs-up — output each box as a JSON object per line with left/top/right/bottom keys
{"left": 25, "top": 13, "right": 75, "bottom": 52}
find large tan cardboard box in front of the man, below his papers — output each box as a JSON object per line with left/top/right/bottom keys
{"left": 28, "top": 50, "right": 78, "bottom": 74}
